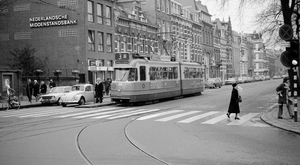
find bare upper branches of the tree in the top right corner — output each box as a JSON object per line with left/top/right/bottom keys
{"left": 217, "top": 0, "right": 300, "bottom": 47}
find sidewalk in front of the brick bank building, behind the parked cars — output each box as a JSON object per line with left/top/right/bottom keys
{"left": 0, "top": 96, "right": 114, "bottom": 110}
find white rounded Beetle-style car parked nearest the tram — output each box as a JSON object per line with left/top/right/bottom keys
{"left": 61, "top": 84, "right": 94, "bottom": 107}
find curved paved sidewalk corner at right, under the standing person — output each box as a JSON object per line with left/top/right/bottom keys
{"left": 260, "top": 105, "right": 300, "bottom": 134}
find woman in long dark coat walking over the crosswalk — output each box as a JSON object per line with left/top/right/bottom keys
{"left": 226, "top": 83, "right": 242, "bottom": 120}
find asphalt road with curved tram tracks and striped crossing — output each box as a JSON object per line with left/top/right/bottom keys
{"left": 0, "top": 80, "right": 300, "bottom": 165}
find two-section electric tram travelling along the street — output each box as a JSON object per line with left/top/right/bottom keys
{"left": 111, "top": 52, "right": 205, "bottom": 103}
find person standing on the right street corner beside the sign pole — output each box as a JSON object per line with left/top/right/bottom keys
{"left": 276, "top": 77, "right": 294, "bottom": 119}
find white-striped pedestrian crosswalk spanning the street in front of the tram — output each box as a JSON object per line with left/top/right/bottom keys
{"left": 0, "top": 107, "right": 269, "bottom": 127}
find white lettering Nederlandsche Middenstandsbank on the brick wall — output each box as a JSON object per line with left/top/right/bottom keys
{"left": 29, "top": 14, "right": 77, "bottom": 28}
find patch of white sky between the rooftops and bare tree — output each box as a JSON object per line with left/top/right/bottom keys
{"left": 201, "top": 0, "right": 263, "bottom": 33}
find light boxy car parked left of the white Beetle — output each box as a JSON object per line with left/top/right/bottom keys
{"left": 40, "top": 86, "right": 72, "bottom": 105}
